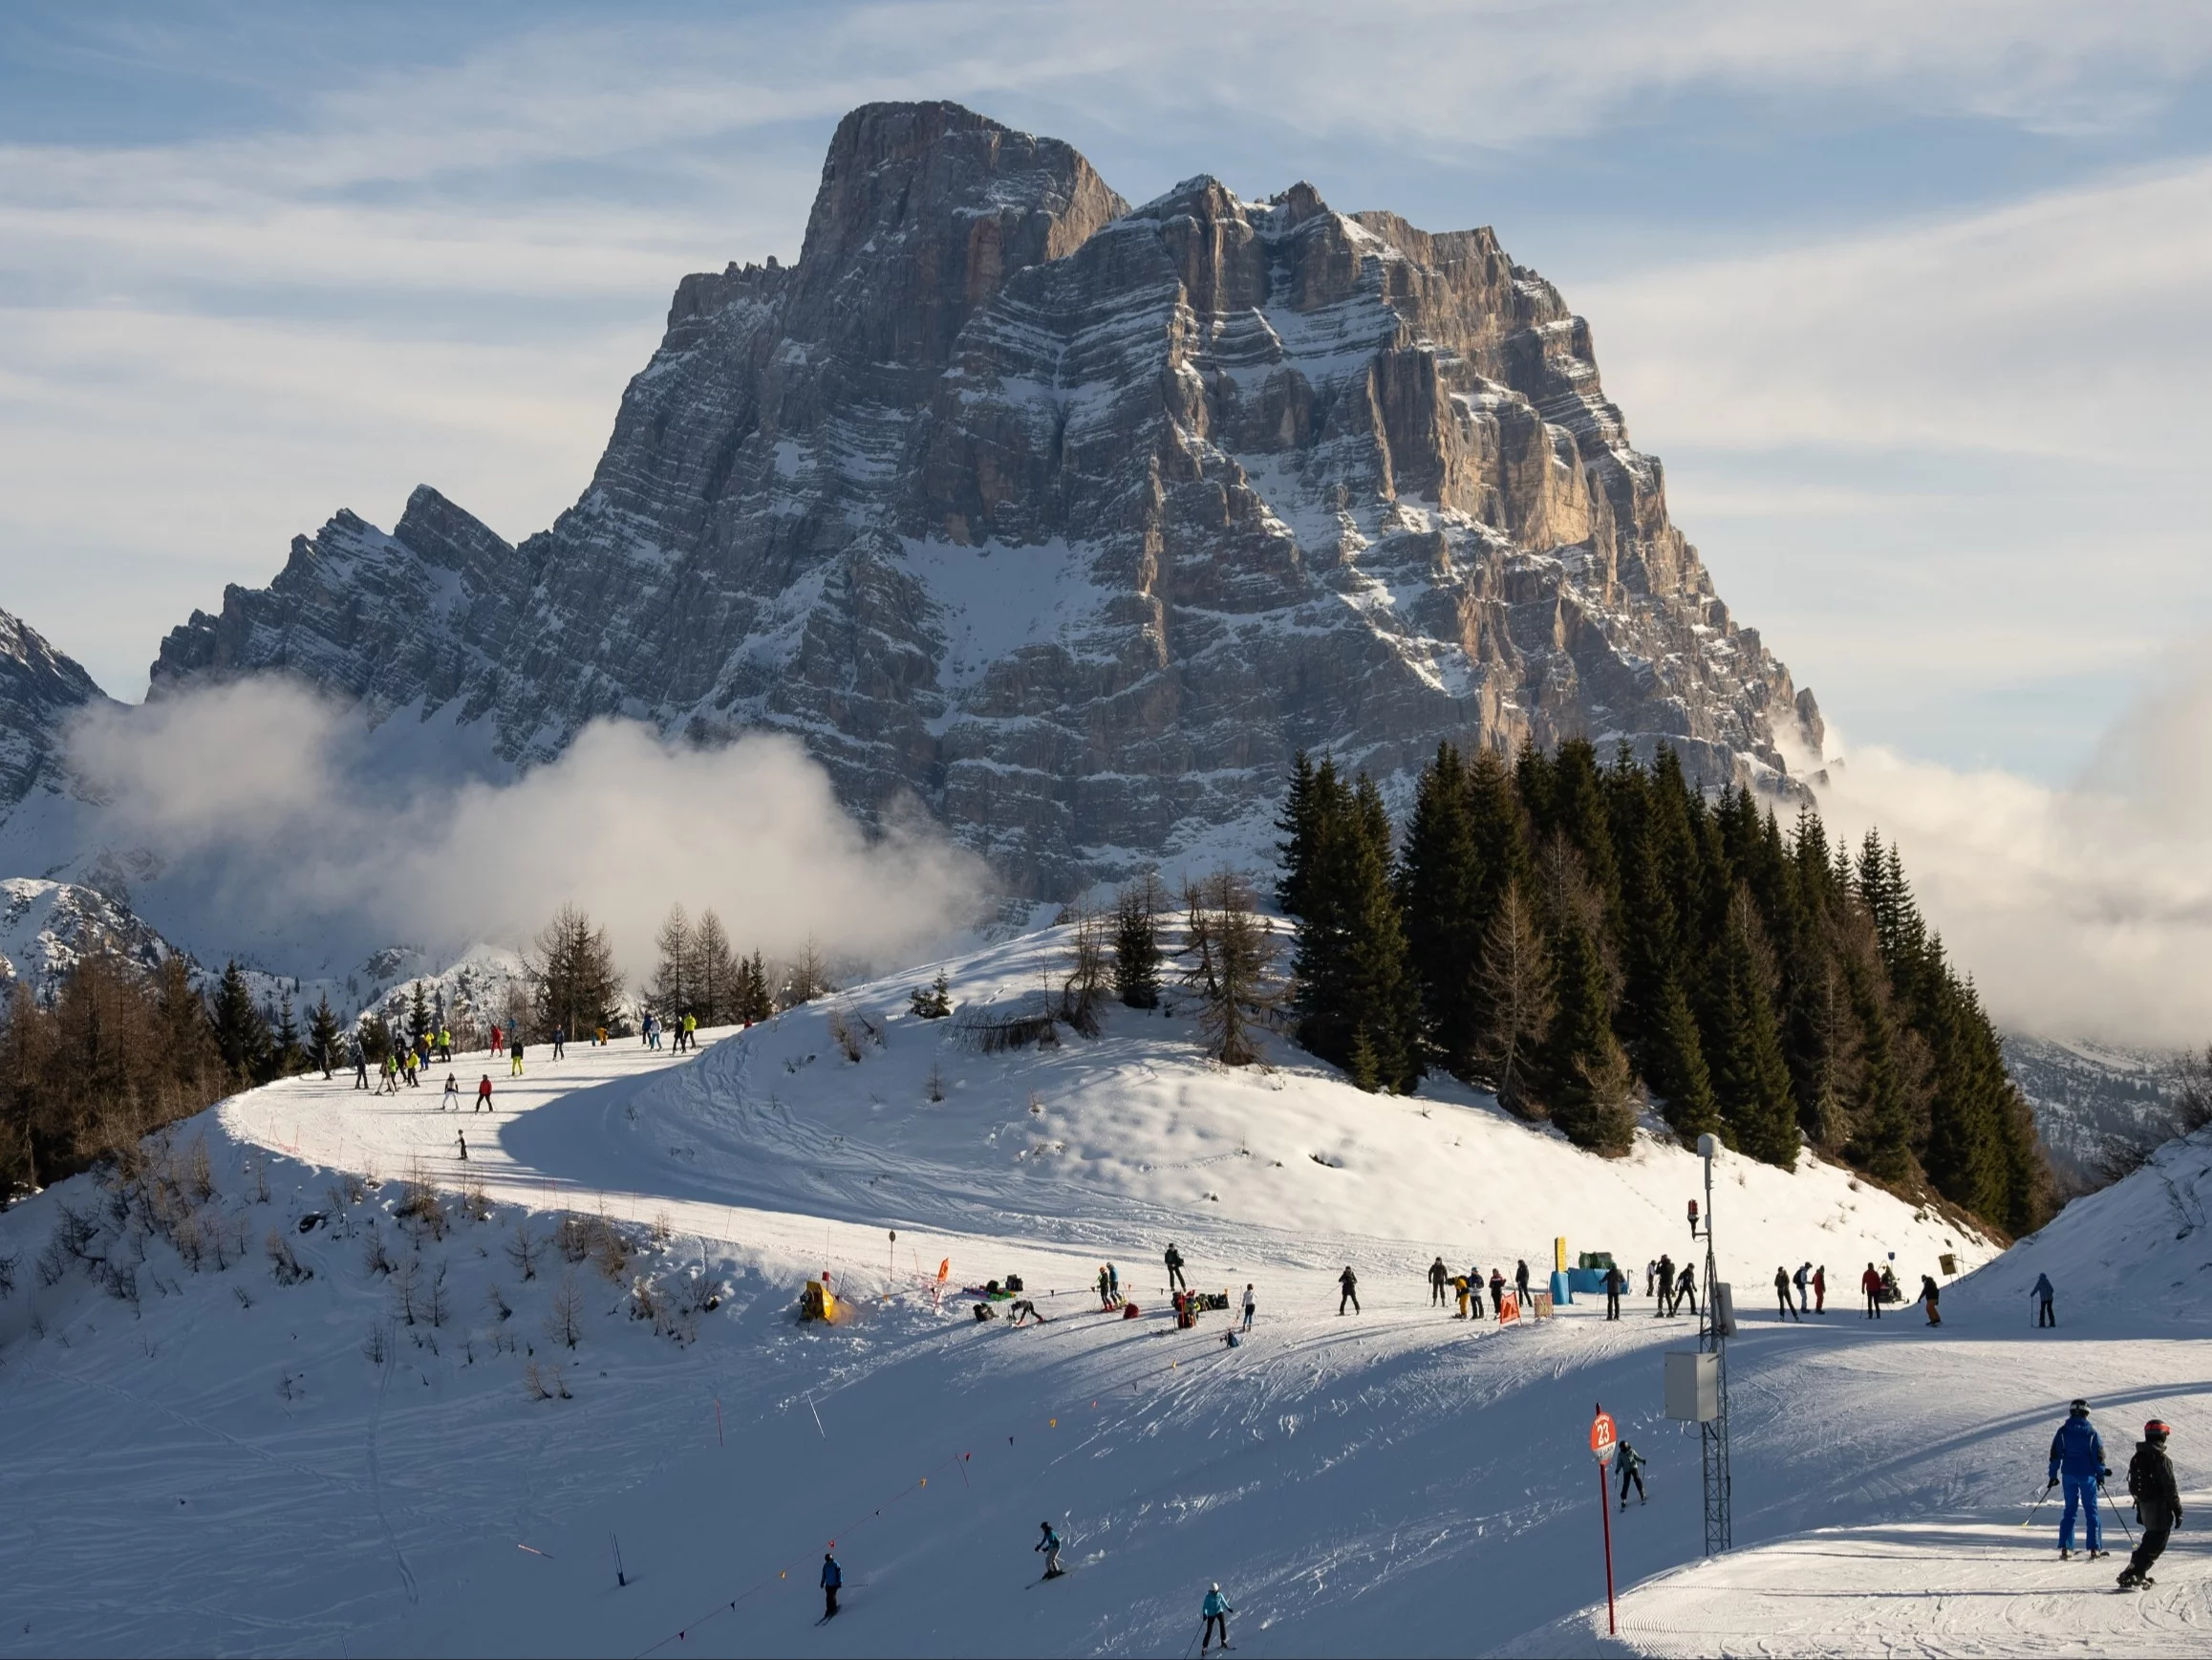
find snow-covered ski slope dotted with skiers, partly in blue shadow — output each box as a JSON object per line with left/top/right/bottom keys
{"left": 0, "top": 934, "right": 2212, "bottom": 1653}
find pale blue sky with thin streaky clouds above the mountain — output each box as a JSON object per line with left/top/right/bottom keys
{"left": 0, "top": 0, "right": 2212, "bottom": 784}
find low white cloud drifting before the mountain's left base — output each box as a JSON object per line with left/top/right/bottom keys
{"left": 71, "top": 679, "right": 984, "bottom": 981}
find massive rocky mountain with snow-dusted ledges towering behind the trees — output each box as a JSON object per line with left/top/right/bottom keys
{"left": 153, "top": 104, "right": 1820, "bottom": 895}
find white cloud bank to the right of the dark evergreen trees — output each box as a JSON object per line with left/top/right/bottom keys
{"left": 1820, "top": 642, "right": 2212, "bottom": 1046}
